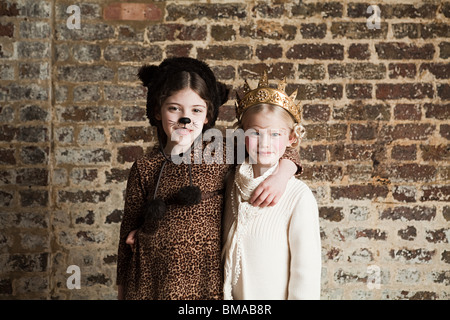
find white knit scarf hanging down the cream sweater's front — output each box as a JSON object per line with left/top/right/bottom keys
{"left": 224, "top": 159, "right": 278, "bottom": 300}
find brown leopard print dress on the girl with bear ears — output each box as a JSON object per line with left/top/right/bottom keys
{"left": 117, "top": 144, "right": 300, "bottom": 300}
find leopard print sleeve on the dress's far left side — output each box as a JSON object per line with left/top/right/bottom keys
{"left": 116, "top": 162, "right": 145, "bottom": 285}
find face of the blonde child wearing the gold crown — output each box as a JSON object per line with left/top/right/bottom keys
{"left": 243, "top": 111, "right": 295, "bottom": 167}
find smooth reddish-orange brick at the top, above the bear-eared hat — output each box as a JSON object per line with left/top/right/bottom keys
{"left": 103, "top": 2, "right": 163, "bottom": 21}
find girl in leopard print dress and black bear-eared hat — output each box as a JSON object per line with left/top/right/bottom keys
{"left": 117, "top": 58, "right": 299, "bottom": 300}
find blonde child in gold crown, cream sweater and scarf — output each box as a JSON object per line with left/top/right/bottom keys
{"left": 223, "top": 70, "right": 321, "bottom": 300}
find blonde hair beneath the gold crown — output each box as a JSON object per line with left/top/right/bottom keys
{"left": 235, "top": 103, "right": 305, "bottom": 150}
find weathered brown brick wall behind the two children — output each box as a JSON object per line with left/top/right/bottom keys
{"left": 0, "top": 0, "right": 450, "bottom": 299}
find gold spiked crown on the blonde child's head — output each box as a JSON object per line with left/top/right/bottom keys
{"left": 236, "top": 71, "right": 301, "bottom": 123}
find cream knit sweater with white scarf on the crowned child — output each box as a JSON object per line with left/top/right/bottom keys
{"left": 222, "top": 163, "right": 321, "bottom": 300}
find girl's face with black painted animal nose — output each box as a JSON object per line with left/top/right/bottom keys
{"left": 155, "top": 88, "right": 208, "bottom": 153}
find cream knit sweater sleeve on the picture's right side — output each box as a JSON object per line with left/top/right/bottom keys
{"left": 288, "top": 185, "right": 322, "bottom": 300}
